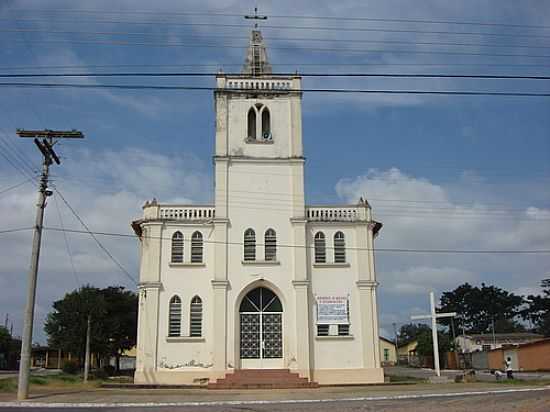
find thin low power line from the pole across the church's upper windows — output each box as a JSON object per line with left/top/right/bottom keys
{"left": 44, "top": 227, "right": 550, "bottom": 255}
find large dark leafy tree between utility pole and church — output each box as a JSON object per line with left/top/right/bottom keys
{"left": 44, "top": 285, "right": 138, "bottom": 370}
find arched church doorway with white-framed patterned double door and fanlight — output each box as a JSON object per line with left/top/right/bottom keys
{"left": 239, "top": 287, "right": 283, "bottom": 369}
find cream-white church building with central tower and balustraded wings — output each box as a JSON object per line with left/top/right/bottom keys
{"left": 132, "top": 30, "right": 384, "bottom": 385}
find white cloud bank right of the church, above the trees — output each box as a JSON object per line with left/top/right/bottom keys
{"left": 335, "top": 168, "right": 550, "bottom": 328}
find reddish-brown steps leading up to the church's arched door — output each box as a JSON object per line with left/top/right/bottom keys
{"left": 208, "top": 369, "right": 319, "bottom": 389}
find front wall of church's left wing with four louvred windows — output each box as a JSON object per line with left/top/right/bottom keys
{"left": 158, "top": 224, "right": 214, "bottom": 371}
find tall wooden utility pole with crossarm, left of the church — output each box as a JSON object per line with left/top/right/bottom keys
{"left": 17, "top": 129, "right": 84, "bottom": 400}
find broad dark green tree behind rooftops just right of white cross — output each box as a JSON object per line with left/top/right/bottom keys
{"left": 439, "top": 283, "right": 525, "bottom": 333}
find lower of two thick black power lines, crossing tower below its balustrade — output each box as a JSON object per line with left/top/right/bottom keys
{"left": 0, "top": 83, "right": 550, "bottom": 97}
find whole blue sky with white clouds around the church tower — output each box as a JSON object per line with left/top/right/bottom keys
{"left": 0, "top": 0, "right": 550, "bottom": 341}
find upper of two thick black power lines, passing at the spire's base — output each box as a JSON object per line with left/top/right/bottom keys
{"left": 0, "top": 72, "right": 550, "bottom": 80}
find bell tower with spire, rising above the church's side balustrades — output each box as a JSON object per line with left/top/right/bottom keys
{"left": 214, "top": 29, "right": 304, "bottom": 218}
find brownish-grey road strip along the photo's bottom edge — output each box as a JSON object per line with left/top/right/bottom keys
{"left": 0, "top": 390, "right": 550, "bottom": 412}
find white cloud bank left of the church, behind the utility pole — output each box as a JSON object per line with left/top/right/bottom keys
{"left": 0, "top": 146, "right": 212, "bottom": 341}
